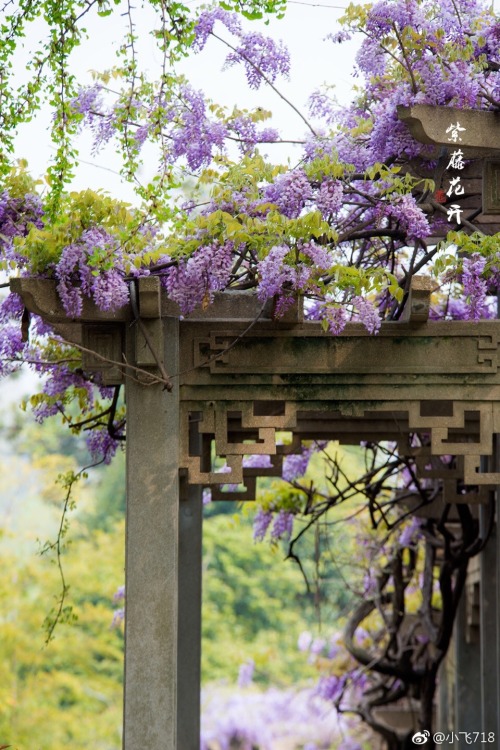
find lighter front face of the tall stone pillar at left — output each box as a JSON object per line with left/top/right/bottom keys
{"left": 123, "top": 318, "right": 179, "bottom": 750}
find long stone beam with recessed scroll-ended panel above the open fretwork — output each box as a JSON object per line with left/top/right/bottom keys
{"left": 190, "top": 321, "right": 500, "bottom": 376}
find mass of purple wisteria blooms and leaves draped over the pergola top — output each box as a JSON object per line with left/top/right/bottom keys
{"left": 0, "top": 0, "right": 500, "bottom": 464}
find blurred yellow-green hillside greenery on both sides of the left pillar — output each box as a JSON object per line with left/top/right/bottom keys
{"left": 0, "top": 390, "right": 360, "bottom": 750}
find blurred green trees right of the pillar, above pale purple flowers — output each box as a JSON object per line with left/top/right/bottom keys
{"left": 202, "top": 515, "right": 315, "bottom": 685}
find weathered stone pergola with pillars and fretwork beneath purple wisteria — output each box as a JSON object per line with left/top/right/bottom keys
{"left": 11, "top": 103, "right": 500, "bottom": 750}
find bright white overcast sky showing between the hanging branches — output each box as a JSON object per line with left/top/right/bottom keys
{"left": 17, "top": 0, "right": 356, "bottom": 200}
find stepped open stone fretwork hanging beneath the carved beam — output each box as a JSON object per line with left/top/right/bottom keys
{"left": 181, "top": 400, "right": 500, "bottom": 504}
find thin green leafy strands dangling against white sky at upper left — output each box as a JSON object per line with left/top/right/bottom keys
{"left": 0, "top": 0, "right": 286, "bottom": 212}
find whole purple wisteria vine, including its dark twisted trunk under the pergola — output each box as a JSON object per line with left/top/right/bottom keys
{"left": 0, "top": 0, "right": 500, "bottom": 748}
